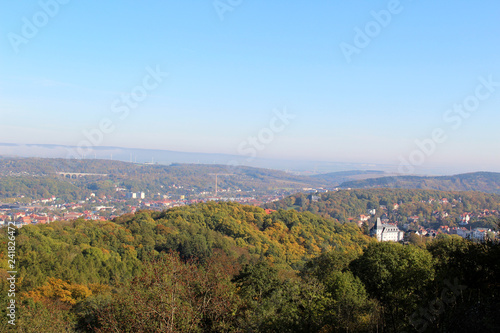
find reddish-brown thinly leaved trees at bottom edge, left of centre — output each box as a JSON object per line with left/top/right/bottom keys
{"left": 93, "top": 253, "right": 243, "bottom": 332}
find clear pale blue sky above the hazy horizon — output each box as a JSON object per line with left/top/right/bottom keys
{"left": 0, "top": 0, "right": 500, "bottom": 172}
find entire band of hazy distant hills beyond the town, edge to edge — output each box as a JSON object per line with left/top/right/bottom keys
{"left": 0, "top": 157, "right": 500, "bottom": 201}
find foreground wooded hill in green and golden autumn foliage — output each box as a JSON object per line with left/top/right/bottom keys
{"left": 0, "top": 202, "right": 500, "bottom": 332}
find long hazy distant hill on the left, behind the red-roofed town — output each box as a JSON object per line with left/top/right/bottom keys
{"left": 0, "top": 157, "right": 328, "bottom": 200}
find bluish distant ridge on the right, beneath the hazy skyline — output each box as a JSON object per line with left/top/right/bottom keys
{"left": 340, "top": 172, "right": 500, "bottom": 194}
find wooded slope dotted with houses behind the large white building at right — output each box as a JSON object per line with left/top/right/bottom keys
{"left": 265, "top": 189, "right": 500, "bottom": 229}
